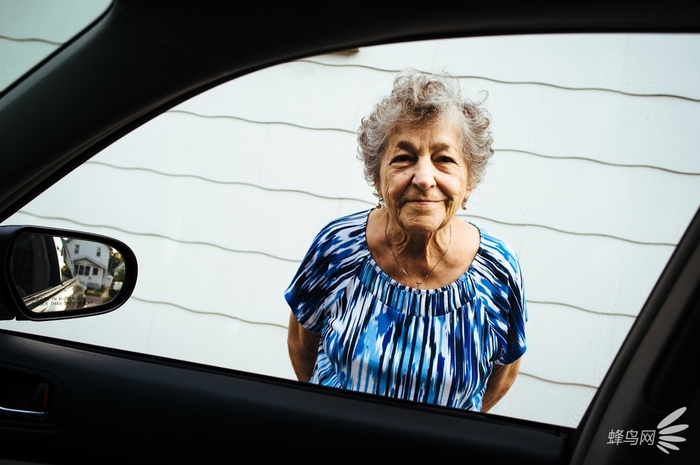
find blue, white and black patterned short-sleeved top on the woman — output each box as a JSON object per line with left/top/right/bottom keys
{"left": 285, "top": 211, "right": 527, "bottom": 411}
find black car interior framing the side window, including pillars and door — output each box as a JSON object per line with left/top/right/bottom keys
{"left": 0, "top": 0, "right": 700, "bottom": 465}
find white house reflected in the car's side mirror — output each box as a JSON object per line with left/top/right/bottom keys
{"left": 66, "top": 239, "right": 113, "bottom": 289}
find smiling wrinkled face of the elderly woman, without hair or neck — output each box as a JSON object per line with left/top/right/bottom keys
{"left": 377, "top": 118, "right": 472, "bottom": 234}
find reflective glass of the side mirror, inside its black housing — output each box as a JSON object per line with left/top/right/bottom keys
{"left": 10, "top": 233, "right": 126, "bottom": 313}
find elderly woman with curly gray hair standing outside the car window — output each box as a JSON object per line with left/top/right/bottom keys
{"left": 285, "top": 71, "right": 527, "bottom": 411}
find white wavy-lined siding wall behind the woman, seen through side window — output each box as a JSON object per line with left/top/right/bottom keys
{"left": 2, "top": 2, "right": 700, "bottom": 426}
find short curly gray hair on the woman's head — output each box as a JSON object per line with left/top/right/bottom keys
{"left": 357, "top": 70, "right": 493, "bottom": 189}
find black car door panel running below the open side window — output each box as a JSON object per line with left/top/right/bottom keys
{"left": 0, "top": 332, "right": 571, "bottom": 464}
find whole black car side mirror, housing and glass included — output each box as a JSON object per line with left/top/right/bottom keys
{"left": 0, "top": 226, "right": 137, "bottom": 320}
